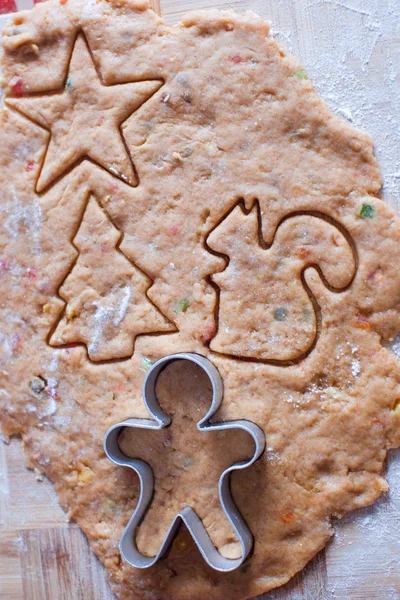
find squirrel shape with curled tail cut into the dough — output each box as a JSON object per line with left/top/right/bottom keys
{"left": 207, "top": 204, "right": 356, "bottom": 361}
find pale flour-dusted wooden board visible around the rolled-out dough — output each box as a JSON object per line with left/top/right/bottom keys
{"left": 0, "top": 0, "right": 400, "bottom": 600}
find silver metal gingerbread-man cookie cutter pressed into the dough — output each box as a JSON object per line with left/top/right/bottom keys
{"left": 104, "top": 353, "right": 265, "bottom": 572}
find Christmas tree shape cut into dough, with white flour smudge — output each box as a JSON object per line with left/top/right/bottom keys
{"left": 50, "top": 196, "right": 176, "bottom": 361}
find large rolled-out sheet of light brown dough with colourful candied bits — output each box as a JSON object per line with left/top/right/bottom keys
{"left": 0, "top": 0, "right": 400, "bottom": 600}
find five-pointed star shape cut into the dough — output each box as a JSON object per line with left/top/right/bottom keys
{"left": 7, "top": 35, "right": 163, "bottom": 192}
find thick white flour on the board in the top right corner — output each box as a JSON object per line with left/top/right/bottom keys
{"left": 268, "top": 0, "right": 400, "bottom": 209}
